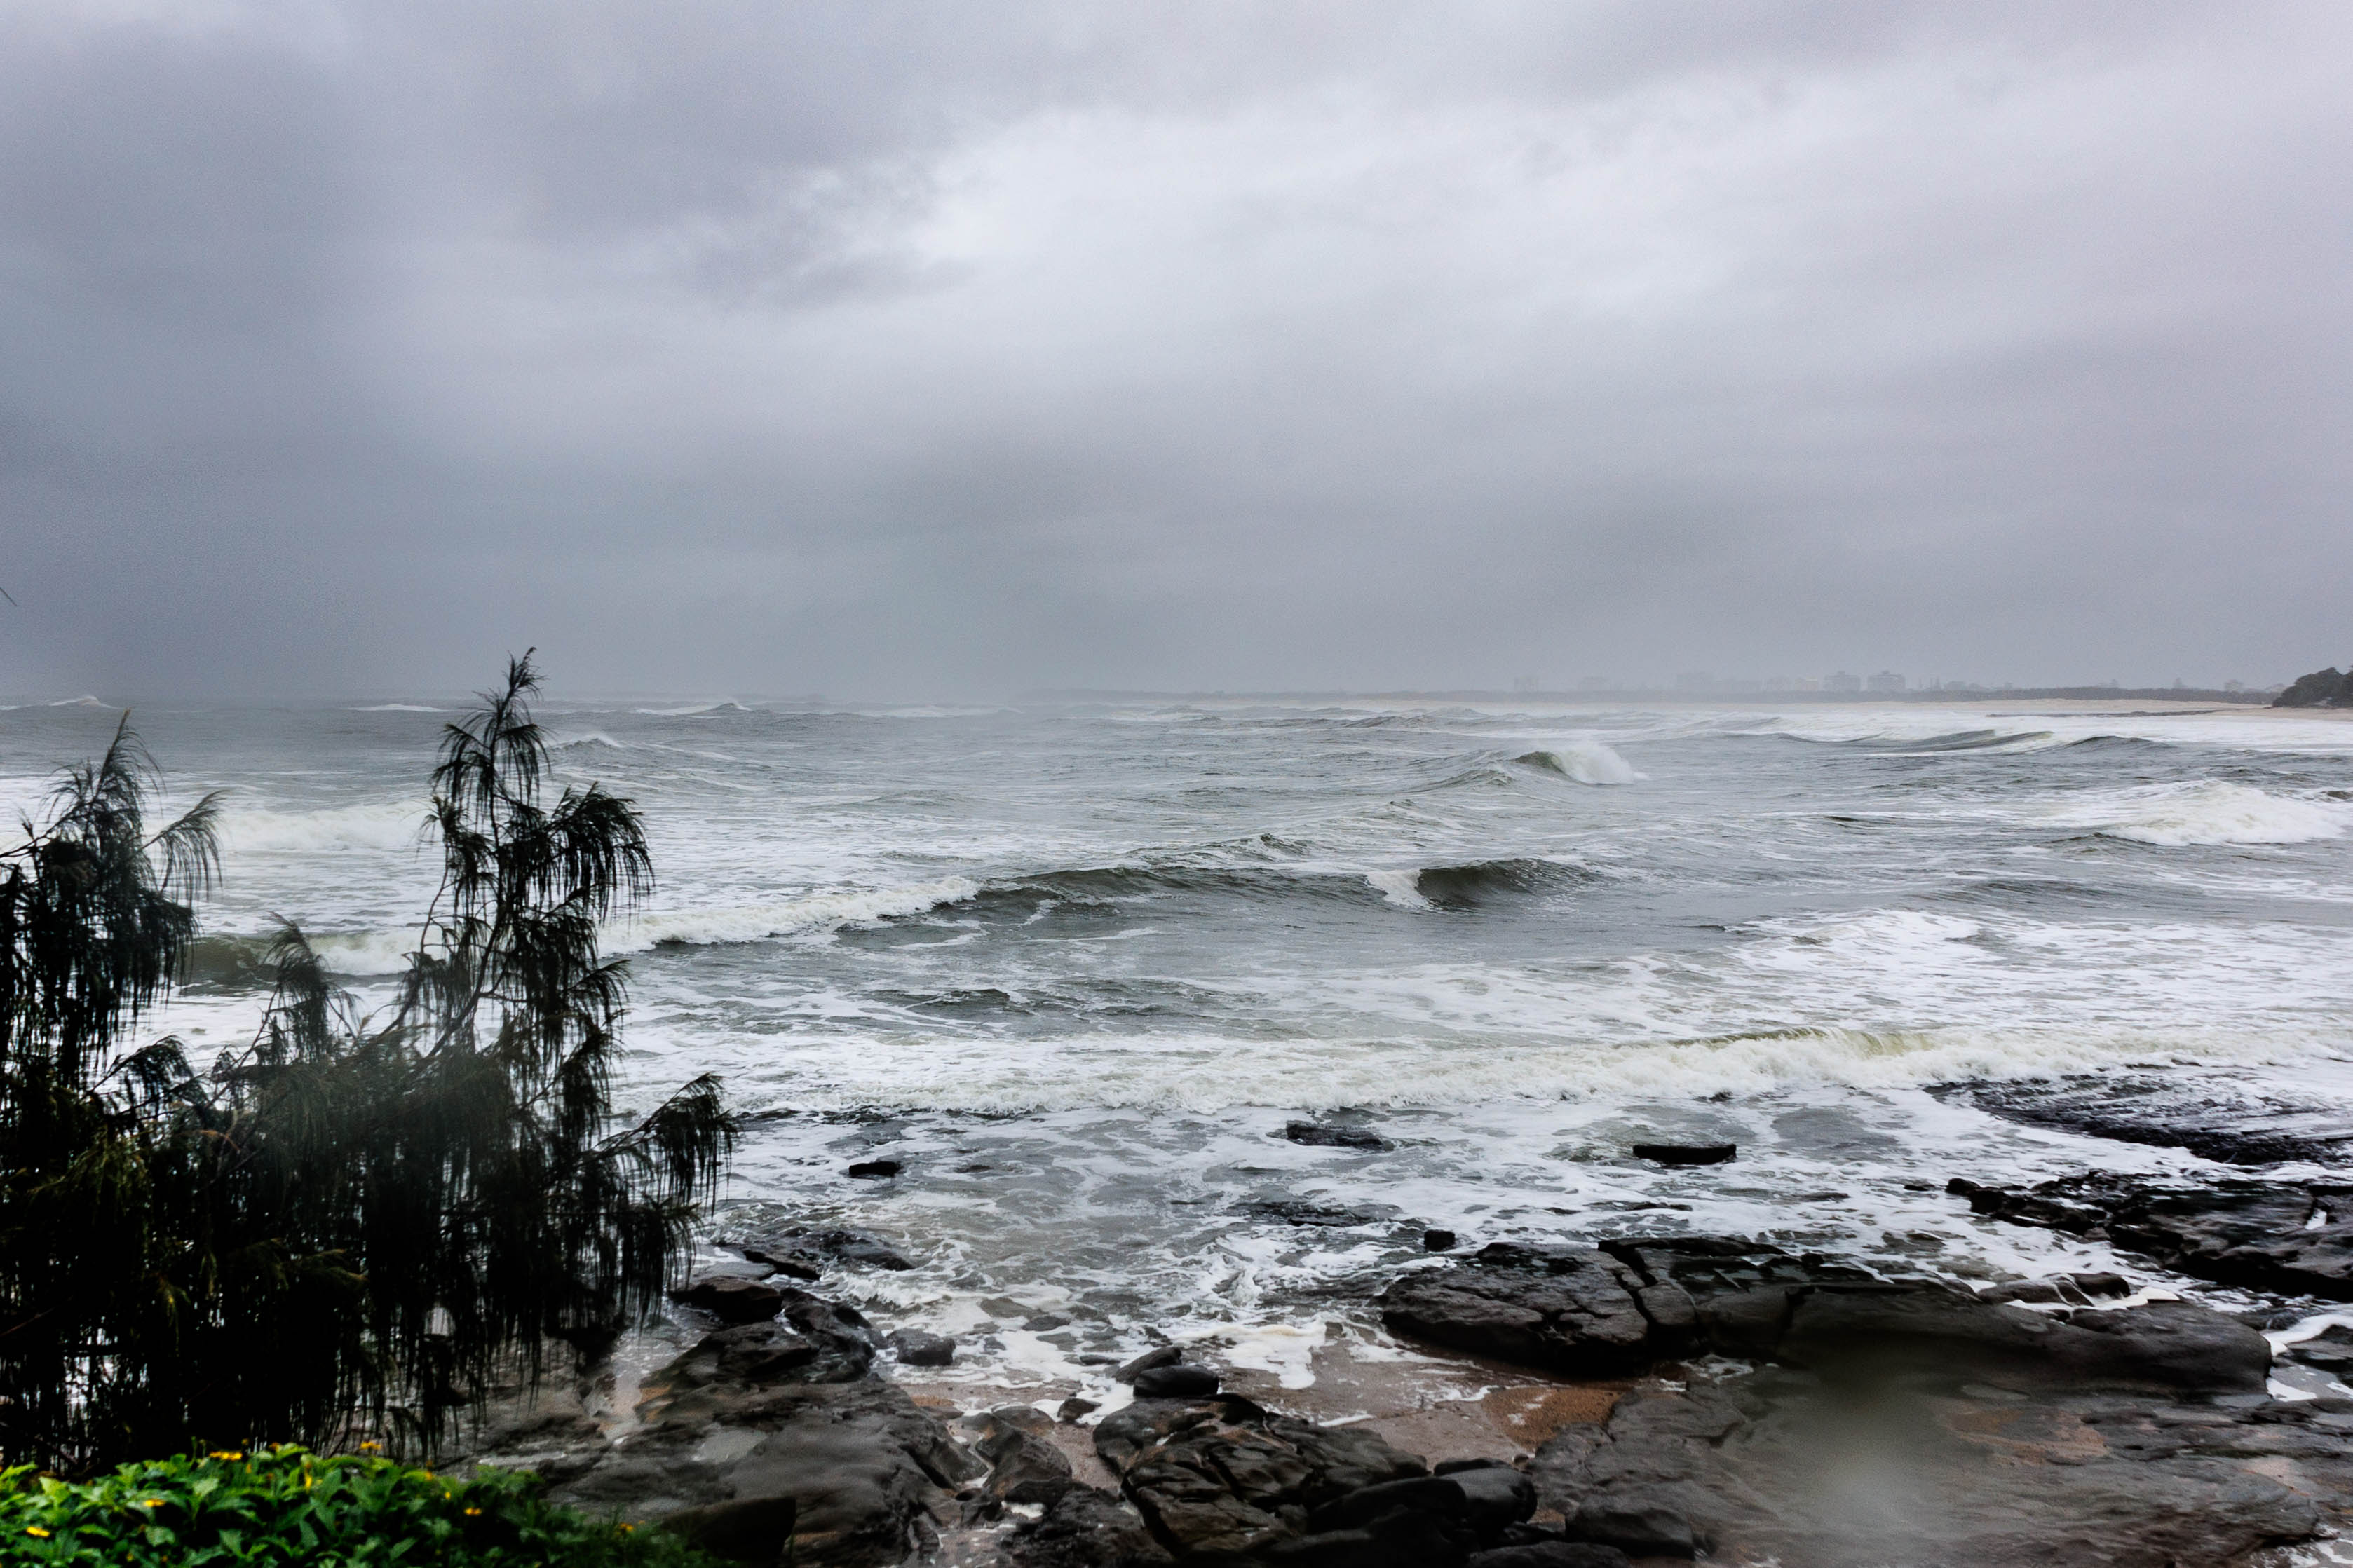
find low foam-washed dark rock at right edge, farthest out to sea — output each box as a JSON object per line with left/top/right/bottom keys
{"left": 1932, "top": 1075, "right": 2353, "bottom": 1166}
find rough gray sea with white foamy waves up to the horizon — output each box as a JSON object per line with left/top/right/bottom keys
{"left": 0, "top": 700, "right": 2353, "bottom": 1384}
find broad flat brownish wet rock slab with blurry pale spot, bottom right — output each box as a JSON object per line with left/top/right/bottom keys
{"left": 1529, "top": 1373, "right": 2315, "bottom": 1568}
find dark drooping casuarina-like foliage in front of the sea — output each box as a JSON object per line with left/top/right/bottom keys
{"left": 0, "top": 656, "right": 734, "bottom": 1469}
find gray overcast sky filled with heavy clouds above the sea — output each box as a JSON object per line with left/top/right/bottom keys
{"left": 0, "top": 0, "right": 2353, "bottom": 696}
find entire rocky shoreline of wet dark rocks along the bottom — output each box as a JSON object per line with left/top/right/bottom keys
{"left": 475, "top": 1152, "right": 2353, "bottom": 1568}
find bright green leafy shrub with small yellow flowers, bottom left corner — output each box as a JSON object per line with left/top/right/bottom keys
{"left": 0, "top": 1446, "right": 718, "bottom": 1568}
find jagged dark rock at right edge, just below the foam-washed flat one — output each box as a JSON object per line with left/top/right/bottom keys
{"left": 1946, "top": 1173, "right": 2353, "bottom": 1300}
